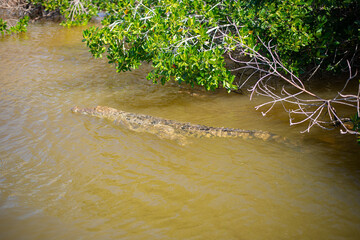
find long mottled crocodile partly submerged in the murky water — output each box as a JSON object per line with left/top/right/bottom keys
{"left": 71, "top": 106, "right": 287, "bottom": 143}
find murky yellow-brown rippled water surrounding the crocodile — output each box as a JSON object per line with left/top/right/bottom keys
{"left": 0, "top": 23, "right": 360, "bottom": 239}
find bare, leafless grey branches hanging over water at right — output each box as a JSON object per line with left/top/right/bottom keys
{"left": 220, "top": 19, "right": 360, "bottom": 135}
